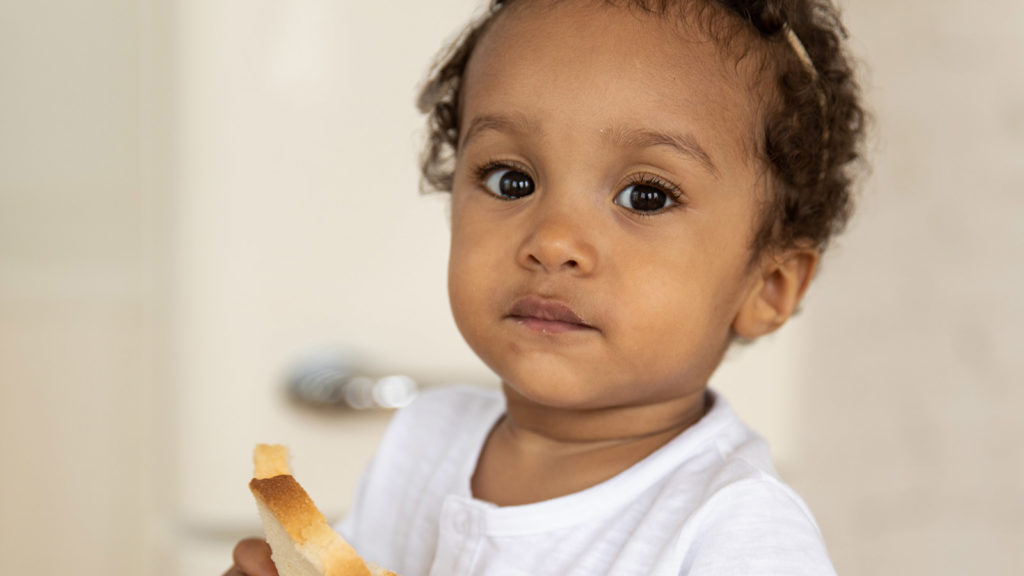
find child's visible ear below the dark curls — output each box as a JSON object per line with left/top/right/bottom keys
{"left": 732, "top": 247, "right": 820, "bottom": 340}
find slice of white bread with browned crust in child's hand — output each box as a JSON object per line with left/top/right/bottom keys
{"left": 249, "top": 444, "right": 395, "bottom": 576}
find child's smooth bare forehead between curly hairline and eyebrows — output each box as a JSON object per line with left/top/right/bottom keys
{"left": 461, "top": 0, "right": 758, "bottom": 168}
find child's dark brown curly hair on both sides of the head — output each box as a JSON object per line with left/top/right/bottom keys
{"left": 418, "top": 0, "right": 865, "bottom": 256}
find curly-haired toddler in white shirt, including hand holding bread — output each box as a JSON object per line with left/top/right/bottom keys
{"left": 228, "top": 0, "right": 862, "bottom": 576}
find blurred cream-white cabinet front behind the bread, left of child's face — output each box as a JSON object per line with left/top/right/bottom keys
{"left": 160, "top": 0, "right": 490, "bottom": 576}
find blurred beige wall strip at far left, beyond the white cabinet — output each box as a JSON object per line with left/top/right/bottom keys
{"left": 0, "top": 0, "right": 155, "bottom": 574}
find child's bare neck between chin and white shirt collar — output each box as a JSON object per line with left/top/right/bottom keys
{"left": 472, "top": 386, "right": 707, "bottom": 506}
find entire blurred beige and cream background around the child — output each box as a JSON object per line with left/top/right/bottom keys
{"left": 0, "top": 0, "right": 1024, "bottom": 576}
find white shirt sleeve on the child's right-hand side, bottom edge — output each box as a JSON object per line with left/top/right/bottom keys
{"left": 680, "top": 479, "right": 836, "bottom": 576}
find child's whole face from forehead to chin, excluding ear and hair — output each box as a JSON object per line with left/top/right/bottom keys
{"left": 449, "top": 2, "right": 763, "bottom": 408}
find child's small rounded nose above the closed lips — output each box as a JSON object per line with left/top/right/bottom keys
{"left": 517, "top": 202, "right": 597, "bottom": 276}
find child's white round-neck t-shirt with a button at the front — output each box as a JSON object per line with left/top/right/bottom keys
{"left": 338, "top": 387, "right": 835, "bottom": 576}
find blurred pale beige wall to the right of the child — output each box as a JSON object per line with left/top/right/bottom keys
{"left": 792, "top": 0, "right": 1024, "bottom": 575}
